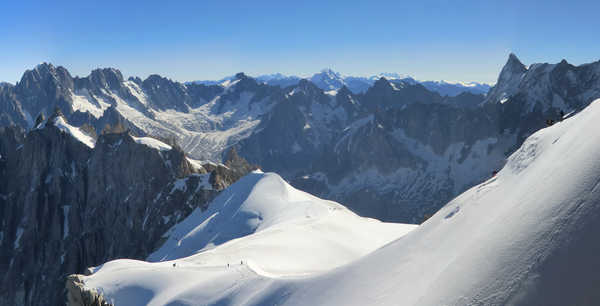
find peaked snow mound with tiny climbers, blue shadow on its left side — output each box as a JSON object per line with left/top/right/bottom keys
{"left": 85, "top": 172, "right": 415, "bottom": 305}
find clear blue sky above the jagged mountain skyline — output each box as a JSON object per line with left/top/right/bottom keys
{"left": 0, "top": 0, "right": 600, "bottom": 83}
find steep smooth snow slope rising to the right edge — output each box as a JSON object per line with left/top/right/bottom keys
{"left": 262, "top": 100, "right": 600, "bottom": 305}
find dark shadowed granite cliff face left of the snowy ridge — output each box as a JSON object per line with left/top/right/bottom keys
{"left": 0, "top": 114, "right": 252, "bottom": 305}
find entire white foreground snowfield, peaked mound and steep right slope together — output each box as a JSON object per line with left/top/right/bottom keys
{"left": 76, "top": 100, "right": 600, "bottom": 305}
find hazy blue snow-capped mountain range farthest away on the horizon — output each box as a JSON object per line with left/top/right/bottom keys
{"left": 192, "top": 69, "right": 492, "bottom": 97}
